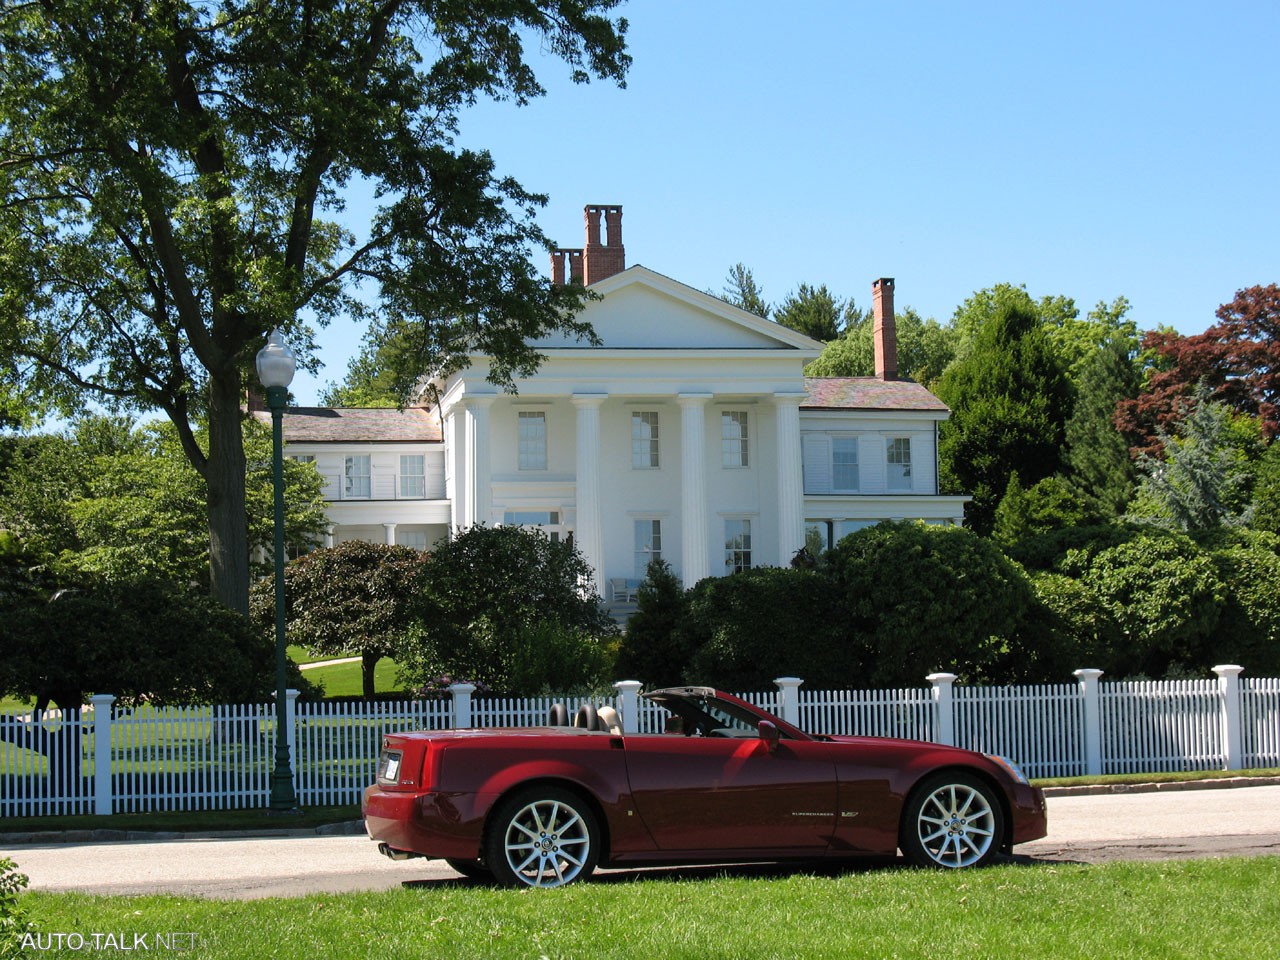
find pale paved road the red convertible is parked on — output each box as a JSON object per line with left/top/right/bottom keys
{"left": 10, "top": 786, "right": 1280, "bottom": 900}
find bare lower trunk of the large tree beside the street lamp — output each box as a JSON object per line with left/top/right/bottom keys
{"left": 205, "top": 367, "right": 248, "bottom": 617}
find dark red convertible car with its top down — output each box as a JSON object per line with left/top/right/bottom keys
{"left": 362, "top": 687, "right": 1047, "bottom": 887}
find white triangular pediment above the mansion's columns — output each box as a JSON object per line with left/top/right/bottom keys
{"left": 534, "top": 266, "right": 822, "bottom": 356}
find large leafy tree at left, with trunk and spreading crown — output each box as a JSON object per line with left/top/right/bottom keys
{"left": 0, "top": 0, "right": 630, "bottom": 611}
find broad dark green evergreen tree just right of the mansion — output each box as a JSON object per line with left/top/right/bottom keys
{"left": 937, "top": 302, "right": 1071, "bottom": 536}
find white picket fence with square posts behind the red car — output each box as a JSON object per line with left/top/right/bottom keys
{"left": 0, "top": 666, "right": 1280, "bottom": 817}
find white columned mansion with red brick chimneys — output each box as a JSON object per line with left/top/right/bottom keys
{"left": 272, "top": 206, "right": 966, "bottom": 600}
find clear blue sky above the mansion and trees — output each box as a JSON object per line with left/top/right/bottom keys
{"left": 293, "top": 0, "right": 1280, "bottom": 404}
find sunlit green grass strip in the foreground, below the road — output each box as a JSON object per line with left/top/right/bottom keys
{"left": 19, "top": 858, "right": 1280, "bottom": 960}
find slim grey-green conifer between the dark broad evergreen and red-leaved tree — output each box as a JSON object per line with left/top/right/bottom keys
{"left": 1064, "top": 337, "right": 1140, "bottom": 520}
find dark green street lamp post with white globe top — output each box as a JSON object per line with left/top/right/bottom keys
{"left": 257, "top": 329, "right": 298, "bottom": 813}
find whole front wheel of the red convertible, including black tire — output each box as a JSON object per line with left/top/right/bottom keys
{"left": 899, "top": 771, "right": 1005, "bottom": 869}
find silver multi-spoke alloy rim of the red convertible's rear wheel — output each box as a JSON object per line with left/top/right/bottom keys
{"left": 503, "top": 799, "right": 591, "bottom": 887}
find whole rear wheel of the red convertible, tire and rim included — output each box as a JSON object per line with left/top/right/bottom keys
{"left": 485, "top": 786, "right": 600, "bottom": 887}
